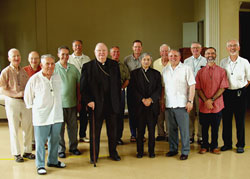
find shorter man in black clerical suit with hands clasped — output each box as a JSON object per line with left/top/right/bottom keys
{"left": 130, "top": 54, "right": 162, "bottom": 158}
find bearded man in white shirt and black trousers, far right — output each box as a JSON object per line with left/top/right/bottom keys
{"left": 220, "top": 40, "right": 250, "bottom": 153}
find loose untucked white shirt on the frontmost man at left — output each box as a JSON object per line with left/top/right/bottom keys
{"left": 24, "top": 71, "right": 63, "bottom": 126}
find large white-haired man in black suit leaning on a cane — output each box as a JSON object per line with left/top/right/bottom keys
{"left": 80, "top": 43, "right": 121, "bottom": 164}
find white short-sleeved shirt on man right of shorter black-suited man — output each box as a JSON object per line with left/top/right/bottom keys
{"left": 162, "top": 62, "right": 195, "bottom": 108}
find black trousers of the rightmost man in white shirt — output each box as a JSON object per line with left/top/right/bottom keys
{"left": 222, "top": 88, "right": 247, "bottom": 147}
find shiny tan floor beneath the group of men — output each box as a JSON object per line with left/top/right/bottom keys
{"left": 0, "top": 110, "right": 250, "bottom": 179}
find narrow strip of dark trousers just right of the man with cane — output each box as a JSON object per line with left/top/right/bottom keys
{"left": 117, "top": 90, "right": 125, "bottom": 140}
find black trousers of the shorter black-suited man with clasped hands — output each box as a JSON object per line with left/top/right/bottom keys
{"left": 136, "top": 107, "right": 157, "bottom": 155}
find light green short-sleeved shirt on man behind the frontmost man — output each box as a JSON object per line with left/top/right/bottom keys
{"left": 55, "top": 61, "right": 80, "bottom": 108}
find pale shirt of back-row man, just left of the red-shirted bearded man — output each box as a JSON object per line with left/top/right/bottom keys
{"left": 184, "top": 55, "right": 207, "bottom": 76}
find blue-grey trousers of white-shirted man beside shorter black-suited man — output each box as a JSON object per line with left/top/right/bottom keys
{"left": 167, "top": 108, "right": 190, "bottom": 155}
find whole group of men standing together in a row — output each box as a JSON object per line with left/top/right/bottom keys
{"left": 0, "top": 40, "right": 250, "bottom": 174}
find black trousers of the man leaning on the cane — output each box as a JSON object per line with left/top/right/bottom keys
{"left": 89, "top": 110, "right": 118, "bottom": 160}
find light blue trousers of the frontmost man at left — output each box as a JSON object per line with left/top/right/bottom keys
{"left": 34, "top": 123, "right": 62, "bottom": 168}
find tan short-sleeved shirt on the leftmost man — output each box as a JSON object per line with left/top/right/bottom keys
{"left": 0, "top": 64, "right": 29, "bottom": 98}
